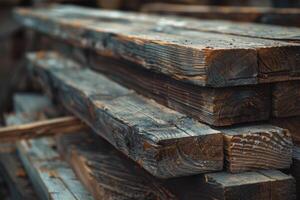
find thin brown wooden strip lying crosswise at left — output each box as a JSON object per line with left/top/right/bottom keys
{"left": 0, "top": 115, "right": 87, "bottom": 143}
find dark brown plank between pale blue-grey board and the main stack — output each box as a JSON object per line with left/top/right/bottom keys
{"left": 57, "top": 132, "right": 177, "bottom": 200}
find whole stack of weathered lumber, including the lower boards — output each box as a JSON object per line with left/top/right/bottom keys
{"left": 0, "top": 3, "right": 300, "bottom": 200}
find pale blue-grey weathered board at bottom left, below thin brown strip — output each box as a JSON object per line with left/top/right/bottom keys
{"left": 18, "top": 138, "right": 93, "bottom": 200}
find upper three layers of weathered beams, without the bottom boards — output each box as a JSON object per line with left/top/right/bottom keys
{"left": 6, "top": 3, "right": 300, "bottom": 199}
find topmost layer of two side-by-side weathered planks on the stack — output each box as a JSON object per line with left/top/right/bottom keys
{"left": 16, "top": 4, "right": 300, "bottom": 87}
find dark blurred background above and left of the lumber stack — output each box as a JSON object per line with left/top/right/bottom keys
{"left": 0, "top": 0, "right": 300, "bottom": 120}
